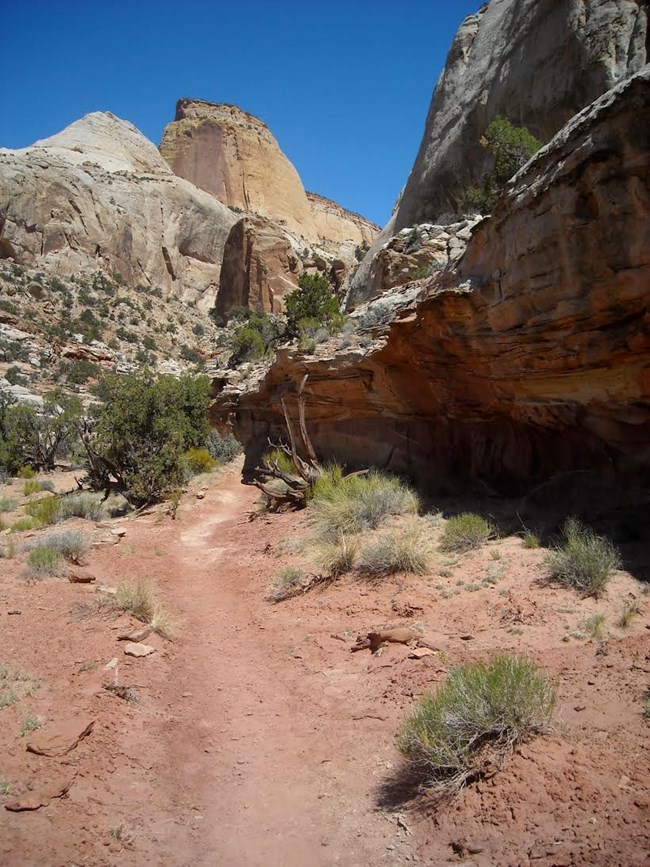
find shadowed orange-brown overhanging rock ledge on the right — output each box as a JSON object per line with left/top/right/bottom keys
{"left": 213, "top": 67, "right": 650, "bottom": 505}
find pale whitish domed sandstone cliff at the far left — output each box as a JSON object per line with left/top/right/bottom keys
{"left": 0, "top": 112, "right": 237, "bottom": 309}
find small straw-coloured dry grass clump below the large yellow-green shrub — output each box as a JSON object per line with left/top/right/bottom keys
{"left": 357, "top": 522, "right": 431, "bottom": 578}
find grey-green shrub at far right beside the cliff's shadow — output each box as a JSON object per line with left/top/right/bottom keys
{"left": 544, "top": 518, "right": 621, "bottom": 597}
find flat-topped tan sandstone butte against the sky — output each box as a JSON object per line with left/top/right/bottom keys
{"left": 160, "top": 99, "right": 378, "bottom": 252}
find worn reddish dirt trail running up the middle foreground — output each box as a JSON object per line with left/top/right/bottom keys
{"left": 147, "top": 475, "right": 402, "bottom": 867}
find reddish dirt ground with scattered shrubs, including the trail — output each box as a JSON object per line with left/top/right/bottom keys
{"left": 0, "top": 469, "right": 650, "bottom": 867}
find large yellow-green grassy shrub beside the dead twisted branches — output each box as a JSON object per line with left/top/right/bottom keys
{"left": 309, "top": 465, "right": 420, "bottom": 542}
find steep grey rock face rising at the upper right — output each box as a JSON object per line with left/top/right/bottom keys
{"left": 350, "top": 0, "right": 648, "bottom": 303}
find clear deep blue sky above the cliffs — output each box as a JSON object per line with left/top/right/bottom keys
{"left": 0, "top": 0, "right": 481, "bottom": 225}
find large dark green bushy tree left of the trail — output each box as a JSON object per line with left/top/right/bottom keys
{"left": 84, "top": 370, "right": 210, "bottom": 506}
